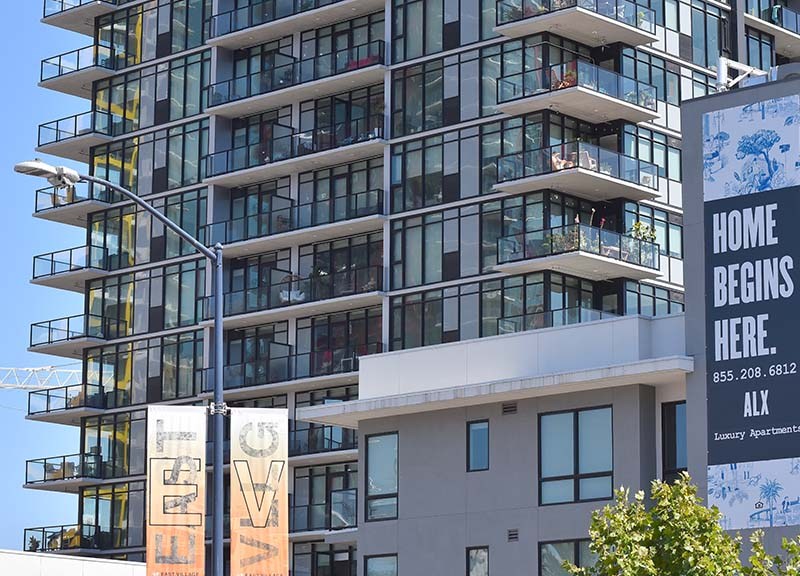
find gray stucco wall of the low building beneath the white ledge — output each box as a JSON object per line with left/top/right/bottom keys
{"left": 358, "top": 386, "right": 656, "bottom": 576}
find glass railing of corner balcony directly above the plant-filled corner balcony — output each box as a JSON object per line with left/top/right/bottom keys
{"left": 497, "top": 142, "right": 658, "bottom": 190}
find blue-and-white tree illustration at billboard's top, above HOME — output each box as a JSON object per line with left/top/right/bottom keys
{"left": 703, "top": 94, "right": 800, "bottom": 202}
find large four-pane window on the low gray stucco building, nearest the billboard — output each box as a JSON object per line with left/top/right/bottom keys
{"left": 539, "top": 407, "right": 613, "bottom": 505}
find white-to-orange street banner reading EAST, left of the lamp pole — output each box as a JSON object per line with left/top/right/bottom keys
{"left": 147, "top": 406, "right": 207, "bottom": 576}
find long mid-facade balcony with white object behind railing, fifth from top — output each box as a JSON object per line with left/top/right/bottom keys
{"left": 201, "top": 266, "right": 383, "bottom": 329}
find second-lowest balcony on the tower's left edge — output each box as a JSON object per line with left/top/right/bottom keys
{"left": 25, "top": 454, "right": 102, "bottom": 493}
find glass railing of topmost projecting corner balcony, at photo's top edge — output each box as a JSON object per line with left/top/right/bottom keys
{"left": 497, "top": 0, "right": 656, "bottom": 34}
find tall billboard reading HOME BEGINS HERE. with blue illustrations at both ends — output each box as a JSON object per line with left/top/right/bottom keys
{"left": 703, "top": 95, "right": 800, "bottom": 529}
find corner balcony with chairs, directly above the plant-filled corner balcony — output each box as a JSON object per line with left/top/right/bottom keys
{"left": 493, "top": 142, "right": 658, "bottom": 201}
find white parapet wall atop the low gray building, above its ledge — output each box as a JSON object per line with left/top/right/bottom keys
{"left": 359, "top": 315, "right": 686, "bottom": 400}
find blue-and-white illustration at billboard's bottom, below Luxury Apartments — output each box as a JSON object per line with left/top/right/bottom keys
{"left": 708, "top": 458, "right": 800, "bottom": 530}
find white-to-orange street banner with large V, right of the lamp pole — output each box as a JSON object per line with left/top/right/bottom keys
{"left": 231, "top": 408, "right": 289, "bottom": 576}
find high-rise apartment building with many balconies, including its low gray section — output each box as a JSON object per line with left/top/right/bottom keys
{"left": 24, "top": 0, "right": 800, "bottom": 576}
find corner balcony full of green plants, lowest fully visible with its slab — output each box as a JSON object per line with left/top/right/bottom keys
{"left": 494, "top": 224, "right": 660, "bottom": 280}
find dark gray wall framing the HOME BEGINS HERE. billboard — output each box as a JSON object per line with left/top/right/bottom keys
{"left": 681, "top": 74, "right": 800, "bottom": 551}
